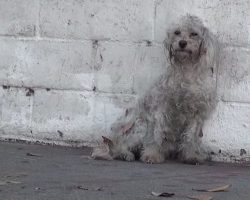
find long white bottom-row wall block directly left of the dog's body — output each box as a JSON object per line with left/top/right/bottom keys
{"left": 32, "top": 90, "right": 136, "bottom": 142}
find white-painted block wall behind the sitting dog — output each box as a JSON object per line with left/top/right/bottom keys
{"left": 0, "top": 0, "right": 250, "bottom": 161}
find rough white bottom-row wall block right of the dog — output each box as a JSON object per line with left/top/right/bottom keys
{"left": 203, "top": 102, "right": 250, "bottom": 161}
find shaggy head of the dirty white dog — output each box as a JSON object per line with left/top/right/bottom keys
{"left": 164, "top": 15, "right": 215, "bottom": 65}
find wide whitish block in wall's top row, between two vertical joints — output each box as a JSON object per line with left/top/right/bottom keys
{"left": 40, "top": 0, "right": 154, "bottom": 40}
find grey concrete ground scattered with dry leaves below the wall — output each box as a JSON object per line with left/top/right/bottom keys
{"left": 0, "top": 142, "right": 250, "bottom": 200}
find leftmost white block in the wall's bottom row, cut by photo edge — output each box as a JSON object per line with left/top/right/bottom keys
{"left": 0, "top": 87, "right": 33, "bottom": 135}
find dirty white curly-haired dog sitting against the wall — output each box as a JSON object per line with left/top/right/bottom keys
{"left": 92, "top": 15, "right": 218, "bottom": 163}
